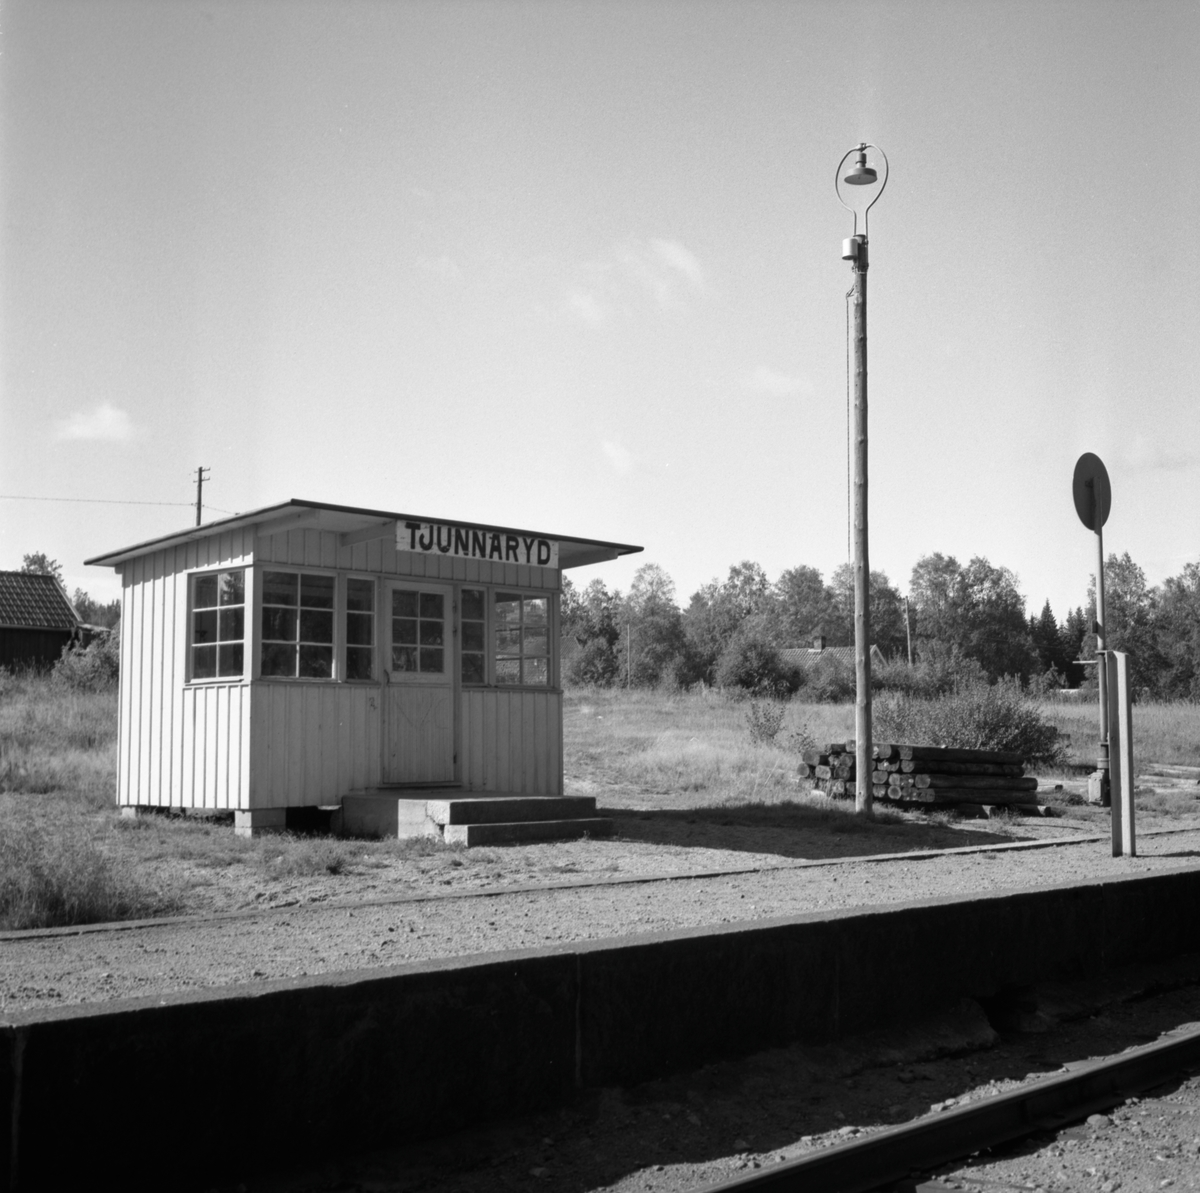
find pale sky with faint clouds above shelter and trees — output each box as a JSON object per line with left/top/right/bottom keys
{"left": 0, "top": 0, "right": 1200, "bottom": 618}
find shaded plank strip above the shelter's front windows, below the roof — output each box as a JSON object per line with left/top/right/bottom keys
{"left": 254, "top": 530, "right": 559, "bottom": 592}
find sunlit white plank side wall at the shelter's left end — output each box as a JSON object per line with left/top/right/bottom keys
{"left": 116, "top": 530, "right": 253, "bottom": 808}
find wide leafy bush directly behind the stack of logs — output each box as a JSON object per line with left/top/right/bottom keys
{"left": 874, "top": 679, "right": 1063, "bottom": 763}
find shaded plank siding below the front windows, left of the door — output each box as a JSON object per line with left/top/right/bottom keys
{"left": 250, "top": 682, "right": 382, "bottom": 808}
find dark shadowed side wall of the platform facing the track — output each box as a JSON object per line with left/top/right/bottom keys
{"left": 7, "top": 865, "right": 1200, "bottom": 1191}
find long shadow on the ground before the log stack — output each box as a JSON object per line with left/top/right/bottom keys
{"left": 601, "top": 803, "right": 1022, "bottom": 861}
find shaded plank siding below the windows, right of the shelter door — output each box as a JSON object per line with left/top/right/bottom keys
{"left": 460, "top": 688, "right": 563, "bottom": 796}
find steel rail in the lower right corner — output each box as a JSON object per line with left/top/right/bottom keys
{"left": 696, "top": 1012, "right": 1200, "bottom": 1193}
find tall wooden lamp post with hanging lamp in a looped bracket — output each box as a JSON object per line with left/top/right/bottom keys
{"left": 834, "top": 142, "right": 888, "bottom": 816}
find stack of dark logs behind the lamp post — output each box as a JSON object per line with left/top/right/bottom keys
{"left": 800, "top": 742, "right": 1038, "bottom": 804}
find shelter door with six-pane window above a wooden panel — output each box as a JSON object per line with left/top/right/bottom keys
{"left": 383, "top": 581, "right": 455, "bottom": 784}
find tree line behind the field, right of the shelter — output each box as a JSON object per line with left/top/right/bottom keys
{"left": 563, "top": 552, "right": 1200, "bottom": 700}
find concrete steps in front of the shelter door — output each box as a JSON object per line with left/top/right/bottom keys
{"left": 342, "top": 789, "right": 613, "bottom": 846}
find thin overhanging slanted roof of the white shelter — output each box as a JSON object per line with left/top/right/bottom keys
{"left": 85, "top": 497, "right": 642, "bottom": 568}
